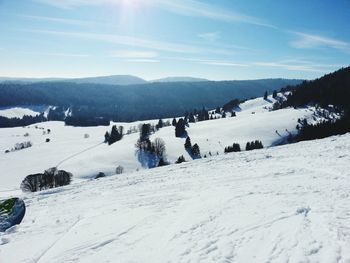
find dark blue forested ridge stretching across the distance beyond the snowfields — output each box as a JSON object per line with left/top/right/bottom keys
{"left": 0, "top": 79, "right": 300, "bottom": 121}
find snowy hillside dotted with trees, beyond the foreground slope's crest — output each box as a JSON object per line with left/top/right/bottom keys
{"left": 0, "top": 98, "right": 313, "bottom": 193}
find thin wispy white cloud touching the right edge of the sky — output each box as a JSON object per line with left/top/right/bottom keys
{"left": 290, "top": 32, "right": 350, "bottom": 53}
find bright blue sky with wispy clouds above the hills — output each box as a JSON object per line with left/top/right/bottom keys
{"left": 0, "top": 0, "right": 350, "bottom": 80}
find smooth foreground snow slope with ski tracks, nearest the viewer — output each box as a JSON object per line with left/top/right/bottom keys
{"left": 0, "top": 134, "right": 350, "bottom": 263}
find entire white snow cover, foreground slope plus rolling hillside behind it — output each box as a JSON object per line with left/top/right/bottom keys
{"left": 0, "top": 94, "right": 350, "bottom": 263}
